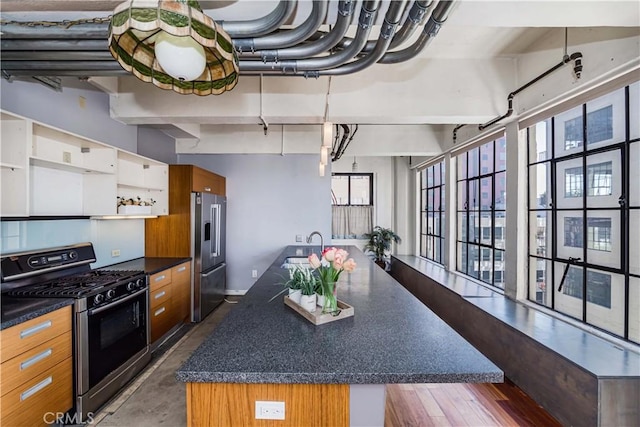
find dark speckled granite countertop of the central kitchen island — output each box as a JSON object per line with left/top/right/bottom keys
{"left": 176, "top": 246, "right": 503, "bottom": 384}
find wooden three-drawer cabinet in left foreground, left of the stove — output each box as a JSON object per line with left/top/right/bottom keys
{"left": 0, "top": 306, "right": 73, "bottom": 426}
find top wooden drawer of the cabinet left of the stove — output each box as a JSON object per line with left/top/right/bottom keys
{"left": 0, "top": 306, "right": 71, "bottom": 362}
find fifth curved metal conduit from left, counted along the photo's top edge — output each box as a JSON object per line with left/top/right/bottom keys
{"left": 318, "top": 0, "right": 408, "bottom": 76}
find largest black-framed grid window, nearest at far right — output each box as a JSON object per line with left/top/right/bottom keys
{"left": 527, "top": 83, "right": 640, "bottom": 343}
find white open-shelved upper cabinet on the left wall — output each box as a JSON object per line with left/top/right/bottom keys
{"left": 0, "top": 112, "right": 169, "bottom": 217}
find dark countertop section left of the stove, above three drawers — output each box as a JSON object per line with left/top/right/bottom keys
{"left": 0, "top": 295, "right": 74, "bottom": 330}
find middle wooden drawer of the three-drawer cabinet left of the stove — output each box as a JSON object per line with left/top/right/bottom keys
{"left": 0, "top": 332, "right": 71, "bottom": 395}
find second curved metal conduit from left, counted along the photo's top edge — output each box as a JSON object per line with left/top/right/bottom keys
{"left": 233, "top": 0, "right": 328, "bottom": 53}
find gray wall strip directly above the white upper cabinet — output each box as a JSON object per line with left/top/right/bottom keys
{"left": 0, "top": 79, "right": 138, "bottom": 153}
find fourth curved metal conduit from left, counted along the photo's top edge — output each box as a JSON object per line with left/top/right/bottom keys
{"left": 240, "top": 0, "right": 380, "bottom": 77}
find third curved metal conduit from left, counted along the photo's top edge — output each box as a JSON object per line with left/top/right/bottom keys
{"left": 240, "top": 0, "right": 355, "bottom": 62}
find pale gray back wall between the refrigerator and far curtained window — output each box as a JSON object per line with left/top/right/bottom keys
{"left": 178, "top": 154, "right": 331, "bottom": 294}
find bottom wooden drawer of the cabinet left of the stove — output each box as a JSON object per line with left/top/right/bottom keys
{"left": 0, "top": 358, "right": 73, "bottom": 426}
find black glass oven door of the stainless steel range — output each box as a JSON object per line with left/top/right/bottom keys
{"left": 78, "top": 289, "right": 149, "bottom": 394}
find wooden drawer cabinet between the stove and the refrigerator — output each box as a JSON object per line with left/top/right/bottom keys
{"left": 149, "top": 261, "right": 191, "bottom": 344}
